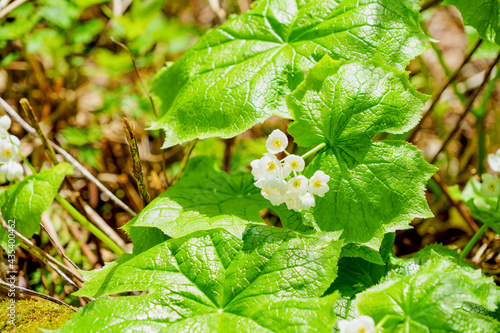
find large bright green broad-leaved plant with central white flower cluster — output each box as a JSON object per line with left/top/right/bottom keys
{"left": 0, "top": 0, "right": 500, "bottom": 333}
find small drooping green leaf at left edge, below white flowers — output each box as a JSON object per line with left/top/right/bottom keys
{"left": 0, "top": 163, "right": 73, "bottom": 250}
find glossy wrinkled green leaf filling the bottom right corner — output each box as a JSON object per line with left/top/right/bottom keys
{"left": 356, "top": 246, "right": 500, "bottom": 333}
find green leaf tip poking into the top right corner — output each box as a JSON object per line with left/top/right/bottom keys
{"left": 443, "top": 0, "right": 500, "bottom": 45}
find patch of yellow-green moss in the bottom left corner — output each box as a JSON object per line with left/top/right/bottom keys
{"left": 0, "top": 298, "right": 74, "bottom": 333}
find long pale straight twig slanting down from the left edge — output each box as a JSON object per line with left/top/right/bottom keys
{"left": 0, "top": 97, "right": 137, "bottom": 216}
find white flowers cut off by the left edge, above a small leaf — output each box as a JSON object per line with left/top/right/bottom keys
{"left": 0, "top": 116, "right": 24, "bottom": 182}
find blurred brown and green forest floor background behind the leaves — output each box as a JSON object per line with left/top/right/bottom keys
{"left": 0, "top": 0, "right": 500, "bottom": 305}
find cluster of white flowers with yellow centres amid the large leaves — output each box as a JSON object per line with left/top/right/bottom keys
{"left": 250, "top": 130, "right": 330, "bottom": 211}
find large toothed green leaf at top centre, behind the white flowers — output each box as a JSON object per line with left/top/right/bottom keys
{"left": 151, "top": 0, "right": 426, "bottom": 147}
